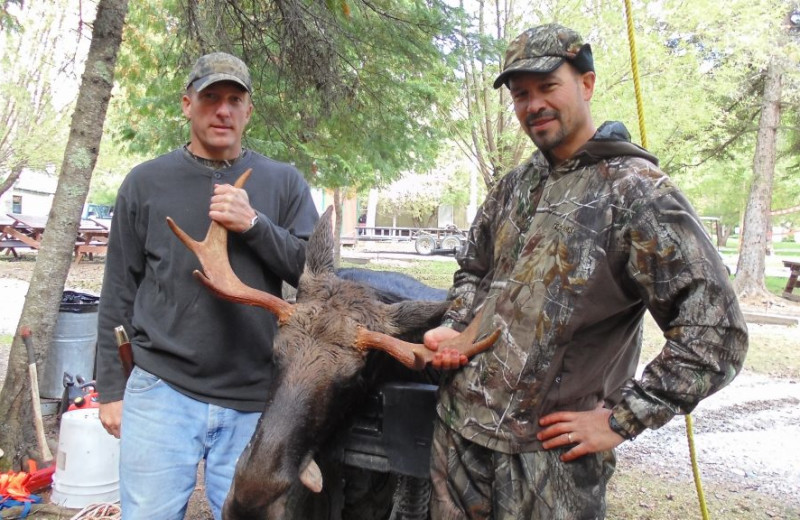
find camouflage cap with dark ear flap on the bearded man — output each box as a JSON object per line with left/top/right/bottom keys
{"left": 494, "top": 23, "right": 594, "bottom": 88}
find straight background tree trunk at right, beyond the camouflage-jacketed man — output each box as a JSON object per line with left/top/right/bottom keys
{"left": 734, "top": 58, "right": 782, "bottom": 299}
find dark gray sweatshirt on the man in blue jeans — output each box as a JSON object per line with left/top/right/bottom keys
{"left": 97, "top": 149, "right": 317, "bottom": 411}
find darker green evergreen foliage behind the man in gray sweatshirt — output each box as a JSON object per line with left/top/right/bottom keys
{"left": 108, "top": 0, "right": 453, "bottom": 189}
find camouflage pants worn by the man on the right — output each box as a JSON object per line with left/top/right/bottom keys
{"left": 431, "top": 421, "right": 616, "bottom": 520}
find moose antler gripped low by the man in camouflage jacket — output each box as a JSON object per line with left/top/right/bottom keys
{"left": 354, "top": 309, "right": 500, "bottom": 370}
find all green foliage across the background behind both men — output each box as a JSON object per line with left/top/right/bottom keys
{"left": 94, "top": 0, "right": 800, "bottom": 227}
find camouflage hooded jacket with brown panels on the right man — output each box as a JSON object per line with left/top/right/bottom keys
{"left": 438, "top": 123, "right": 747, "bottom": 453}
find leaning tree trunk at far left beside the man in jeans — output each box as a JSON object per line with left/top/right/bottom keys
{"left": 0, "top": 0, "right": 128, "bottom": 469}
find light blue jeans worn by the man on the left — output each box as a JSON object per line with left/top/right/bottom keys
{"left": 119, "top": 367, "right": 261, "bottom": 520}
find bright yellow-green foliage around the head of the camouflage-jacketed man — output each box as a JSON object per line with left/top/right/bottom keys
{"left": 451, "top": 0, "right": 800, "bottom": 226}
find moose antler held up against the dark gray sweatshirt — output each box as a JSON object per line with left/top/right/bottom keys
{"left": 167, "top": 168, "right": 294, "bottom": 323}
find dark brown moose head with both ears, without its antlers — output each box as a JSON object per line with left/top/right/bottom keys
{"left": 223, "top": 209, "right": 447, "bottom": 520}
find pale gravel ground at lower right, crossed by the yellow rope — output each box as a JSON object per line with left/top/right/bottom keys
{"left": 617, "top": 372, "right": 800, "bottom": 508}
